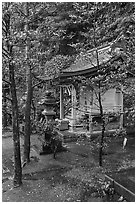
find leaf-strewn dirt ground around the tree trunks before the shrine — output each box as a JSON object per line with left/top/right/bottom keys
{"left": 2, "top": 130, "right": 135, "bottom": 202}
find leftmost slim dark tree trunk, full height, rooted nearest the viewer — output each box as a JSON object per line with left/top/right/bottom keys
{"left": 5, "top": 2, "right": 22, "bottom": 187}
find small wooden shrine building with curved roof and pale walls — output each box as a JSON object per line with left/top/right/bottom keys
{"left": 59, "top": 44, "right": 123, "bottom": 132}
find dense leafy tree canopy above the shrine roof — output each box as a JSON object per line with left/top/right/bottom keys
{"left": 2, "top": 2, "right": 135, "bottom": 82}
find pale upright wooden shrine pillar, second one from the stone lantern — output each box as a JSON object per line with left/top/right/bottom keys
{"left": 71, "top": 85, "right": 76, "bottom": 130}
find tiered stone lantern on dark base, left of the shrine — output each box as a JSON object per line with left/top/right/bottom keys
{"left": 40, "top": 91, "right": 64, "bottom": 158}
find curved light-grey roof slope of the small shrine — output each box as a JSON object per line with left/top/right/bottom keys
{"left": 63, "top": 45, "right": 112, "bottom": 74}
